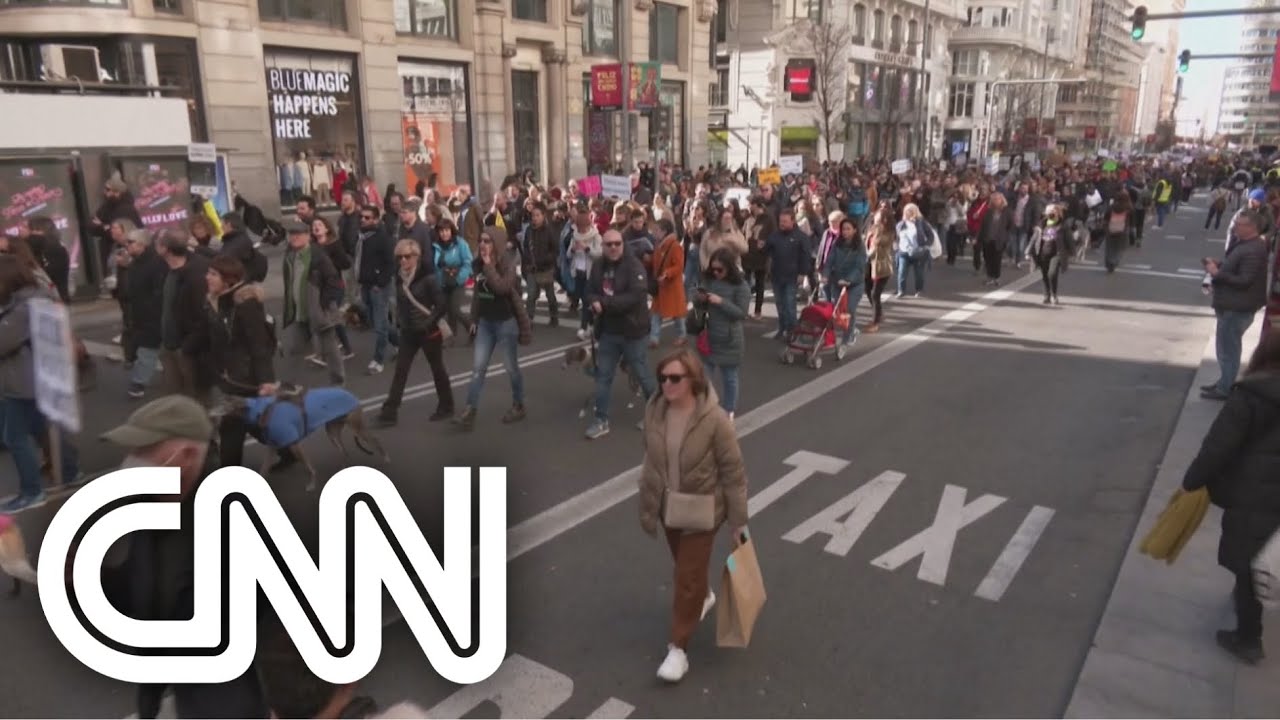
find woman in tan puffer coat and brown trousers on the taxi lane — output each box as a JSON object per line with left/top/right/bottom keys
{"left": 640, "top": 348, "right": 746, "bottom": 683}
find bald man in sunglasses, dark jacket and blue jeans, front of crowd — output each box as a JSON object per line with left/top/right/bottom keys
{"left": 586, "top": 231, "right": 658, "bottom": 439}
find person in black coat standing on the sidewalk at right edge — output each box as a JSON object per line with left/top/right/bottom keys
{"left": 1183, "top": 333, "right": 1280, "bottom": 665}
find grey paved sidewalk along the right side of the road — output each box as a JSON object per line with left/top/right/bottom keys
{"left": 1065, "top": 313, "right": 1280, "bottom": 717}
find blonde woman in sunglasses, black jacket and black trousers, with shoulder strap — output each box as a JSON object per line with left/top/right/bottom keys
{"left": 378, "top": 238, "right": 453, "bottom": 425}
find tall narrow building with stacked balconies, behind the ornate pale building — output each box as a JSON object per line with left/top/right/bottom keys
{"left": 1056, "top": 0, "right": 1143, "bottom": 152}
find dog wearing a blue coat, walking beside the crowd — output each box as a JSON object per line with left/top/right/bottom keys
{"left": 215, "top": 386, "right": 390, "bottom": 492}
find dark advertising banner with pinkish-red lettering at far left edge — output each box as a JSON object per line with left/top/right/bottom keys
{"left": 0, "top": 158, "right": 84, "bottom": 286}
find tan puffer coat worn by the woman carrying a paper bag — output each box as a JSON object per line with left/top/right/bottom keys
{"left": 640, "top": 384, "right": 746, "bottom": 536}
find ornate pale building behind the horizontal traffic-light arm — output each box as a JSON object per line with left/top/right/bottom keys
{"left": 945, "top": 0, "right": 1089, "bottom": 156}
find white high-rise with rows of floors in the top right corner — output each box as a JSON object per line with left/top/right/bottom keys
{"left": 1217, "top": 0, "right": 1280, "bottom": 146}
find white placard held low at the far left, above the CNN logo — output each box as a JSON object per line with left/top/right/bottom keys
{"left": 28, "top": 297, "right": 81, "bottom": 433}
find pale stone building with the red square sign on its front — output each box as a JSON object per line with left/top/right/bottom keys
{"left": 708, "top": 0, "right": 960, "bottom": 167}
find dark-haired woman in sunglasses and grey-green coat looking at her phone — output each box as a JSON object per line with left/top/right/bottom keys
{"left": 694, "top": 247, "right": 751, "bottom": 420}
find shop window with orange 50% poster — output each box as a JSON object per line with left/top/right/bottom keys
{"left": 399, "top": 60, "right": 472, "bottom": 193}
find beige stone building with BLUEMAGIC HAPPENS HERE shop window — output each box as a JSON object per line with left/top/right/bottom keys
{"left": 0, "top": 0, "right": 716, "bottom": 208}
